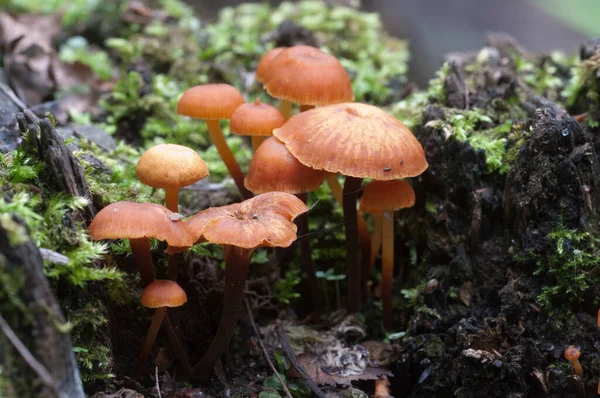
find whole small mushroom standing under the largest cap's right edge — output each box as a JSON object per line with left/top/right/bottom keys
{"left": 360, "top": 180, "right": 415, "bottom": 331}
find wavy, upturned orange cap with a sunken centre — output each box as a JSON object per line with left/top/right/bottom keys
{"left": 186, "top": 192, "right": 308, "bottom": 249}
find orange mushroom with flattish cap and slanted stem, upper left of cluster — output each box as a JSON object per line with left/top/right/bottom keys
{"left": 177, "top": 84, "right": 252, "bottom": 199}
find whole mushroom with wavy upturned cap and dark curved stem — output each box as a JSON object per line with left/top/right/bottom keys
{"left": 186, "top": 192, "right": 308, "bottom": 378}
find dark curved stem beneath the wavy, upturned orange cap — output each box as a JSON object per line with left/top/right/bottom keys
{"left": 192, "top": 245, "right": 254, "bottom": 379}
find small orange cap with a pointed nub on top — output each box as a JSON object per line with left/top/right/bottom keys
{"left": 229, "top": 98, "right": 285, "bottom": 136}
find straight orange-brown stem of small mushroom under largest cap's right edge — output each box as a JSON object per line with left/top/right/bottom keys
{"left": 381, "top": 210, "right": 394, "bottom": 331}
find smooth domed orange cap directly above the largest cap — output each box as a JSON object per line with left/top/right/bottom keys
{"left": 263, "top": 46, "right": 354, "bottom": 106}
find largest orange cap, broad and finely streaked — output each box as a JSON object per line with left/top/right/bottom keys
{"left": 273, "top": 103, "right": 428, "bottom": 180}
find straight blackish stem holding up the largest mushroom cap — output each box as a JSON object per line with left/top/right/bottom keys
{"left": 343, "top": 176, "right": 370, "bottom": 313}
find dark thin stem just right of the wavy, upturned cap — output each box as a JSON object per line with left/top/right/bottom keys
{"left": 296, "top": 193, "right": 325, "bottom": 318}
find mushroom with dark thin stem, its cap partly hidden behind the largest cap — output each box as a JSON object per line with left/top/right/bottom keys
{"left": 246, "top": 137, "right": 327, "bottom": 316}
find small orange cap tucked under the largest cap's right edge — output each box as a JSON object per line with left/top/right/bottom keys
{"left": 360, "top": 180, "right": 415, "bottom": 214}
